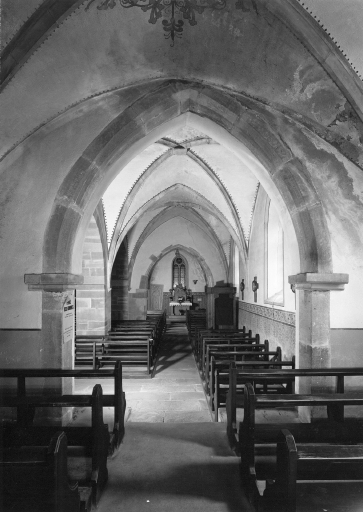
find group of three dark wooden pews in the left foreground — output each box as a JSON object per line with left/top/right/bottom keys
{"left": 0, "top": 362, "right": 126, "bottom": 512}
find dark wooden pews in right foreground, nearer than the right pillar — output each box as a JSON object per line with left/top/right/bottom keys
{"left": 236, "top": 368, "right": 363, "bottom": 512}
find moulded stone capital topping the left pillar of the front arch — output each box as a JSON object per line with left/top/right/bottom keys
{"left": 24, "top": 273, "right": 84, "bottom": 292}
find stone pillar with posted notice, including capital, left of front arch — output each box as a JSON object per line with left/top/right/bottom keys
{"left": 24, "top": 273, "right": 83, "bottom": 421}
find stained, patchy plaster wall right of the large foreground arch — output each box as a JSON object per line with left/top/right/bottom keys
{"left": 288, "top": 129, "right": 363, "bottom": 329}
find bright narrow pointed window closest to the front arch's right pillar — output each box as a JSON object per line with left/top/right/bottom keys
{"left": 265, "top": 202, "right": 284, "bottom": 306}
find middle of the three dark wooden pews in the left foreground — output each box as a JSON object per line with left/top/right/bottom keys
{"left": 2, "top": 384, "right": 109, "bottom": 506}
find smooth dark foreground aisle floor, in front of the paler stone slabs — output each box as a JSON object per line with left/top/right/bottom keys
{"left": 97, "top": 423, "right": 252, "bottom": 512}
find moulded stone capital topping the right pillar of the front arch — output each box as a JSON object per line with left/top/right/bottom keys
{"left": 289, "top": 272, "right": 349, "bottom": 292}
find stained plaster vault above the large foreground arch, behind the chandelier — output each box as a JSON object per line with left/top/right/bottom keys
{"left": 0, "top": 0, "right": 359, "bottom": 161}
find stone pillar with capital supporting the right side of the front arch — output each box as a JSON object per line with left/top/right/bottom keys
{"left": 289, "top": 273, "right": 349, "bottom": 420}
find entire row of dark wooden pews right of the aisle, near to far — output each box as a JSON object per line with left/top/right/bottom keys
{"left": 189, "top": 321, "right": 363, "bottom": 512}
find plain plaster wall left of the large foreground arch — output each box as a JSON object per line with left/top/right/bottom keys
{"left": 0, "top": 89, "right": 145, "bottom": 329}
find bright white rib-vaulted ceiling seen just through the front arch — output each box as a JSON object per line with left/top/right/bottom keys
{"left": 103, "top": 124, "right": 258, "bottom": 272}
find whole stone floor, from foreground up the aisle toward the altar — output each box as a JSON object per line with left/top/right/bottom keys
{"left": 74, "top": 318, "right": 363, "bottom": 512}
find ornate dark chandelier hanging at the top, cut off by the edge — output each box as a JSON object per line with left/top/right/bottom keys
{"left": 86, "top": 0, "right": 228, "bottom": 46}
